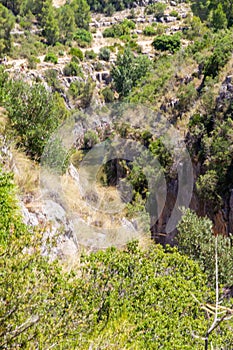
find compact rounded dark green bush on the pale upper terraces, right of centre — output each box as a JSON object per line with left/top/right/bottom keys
{"left": 152, "top": 34, "right": 181, "bottom": 53}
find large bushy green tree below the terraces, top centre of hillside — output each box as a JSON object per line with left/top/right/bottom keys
{"left": 111, "top": 48, "right": 150, "bottom": 97}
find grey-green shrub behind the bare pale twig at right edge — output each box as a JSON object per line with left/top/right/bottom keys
{"left": 177, "top": 209, "right": 233, "bottom": 288}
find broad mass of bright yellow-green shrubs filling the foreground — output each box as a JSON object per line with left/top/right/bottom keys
{"left": 0, "top": 173, "right": 232, "bottom": 350}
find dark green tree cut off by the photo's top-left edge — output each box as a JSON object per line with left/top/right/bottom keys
{"left": 0, "top": 4, "right": 15, "bottom": 57}
